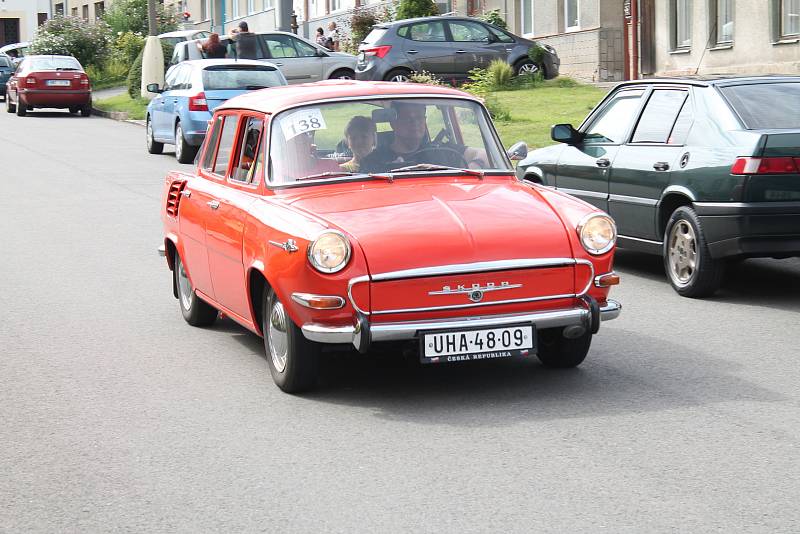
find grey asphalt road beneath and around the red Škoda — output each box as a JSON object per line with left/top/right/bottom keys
{"left": 0, "top": 107, "right": 800, "bottom": 533}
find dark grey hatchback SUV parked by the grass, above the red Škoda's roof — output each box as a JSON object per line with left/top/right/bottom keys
{"left": 356, "top": 17, "right": 560, "bottom": 82}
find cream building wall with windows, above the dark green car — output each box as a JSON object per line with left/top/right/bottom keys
{"left": 642, "top": 0, "right": 800, "bottom": 76}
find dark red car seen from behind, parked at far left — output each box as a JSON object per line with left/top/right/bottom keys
{"left": 6, "top": 56, "right": 92, "bottom": 117}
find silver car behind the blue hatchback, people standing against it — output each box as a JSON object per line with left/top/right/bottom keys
{"left": 170, "top": 32, "right": 356, "bottom": 85}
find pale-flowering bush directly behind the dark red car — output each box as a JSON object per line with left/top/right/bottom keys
{"left": 31, "top": 16, "right": 111, "bottom": 67}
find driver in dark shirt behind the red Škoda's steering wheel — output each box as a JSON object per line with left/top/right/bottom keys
{"left": 360, "top": 101, "right": 486, "bottom": 172}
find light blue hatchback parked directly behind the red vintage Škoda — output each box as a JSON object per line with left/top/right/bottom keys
{"left": 147, "top": 59, "right": 286, "bottom": 163}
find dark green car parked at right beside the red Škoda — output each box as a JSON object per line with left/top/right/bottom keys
{"left": 517, "top": 76, "right": 800, "bottom": 297}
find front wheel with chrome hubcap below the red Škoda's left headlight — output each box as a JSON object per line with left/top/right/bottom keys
{"left": 261, "top": 289, "right": 320, "bottom": 393}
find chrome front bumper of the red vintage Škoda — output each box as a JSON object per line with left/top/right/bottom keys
{"left": 302, "top": 300, "right": 622, "bottom": 350}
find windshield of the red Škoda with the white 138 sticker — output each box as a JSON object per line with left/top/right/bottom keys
{"left": 270, "top": 98, "right": 510, "bottom": 184}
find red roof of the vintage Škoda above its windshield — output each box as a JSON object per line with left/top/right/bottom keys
{"left": 217, "top": 80, "right": 479, "bottom": 114}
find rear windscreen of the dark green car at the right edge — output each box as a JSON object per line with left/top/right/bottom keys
{"left": 720, "top": 82, "right": 800, "bottom": 130}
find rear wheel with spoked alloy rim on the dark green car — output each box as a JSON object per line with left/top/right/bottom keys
{"left": 662, "top": 206, "right": 725, "bottom": 298}
